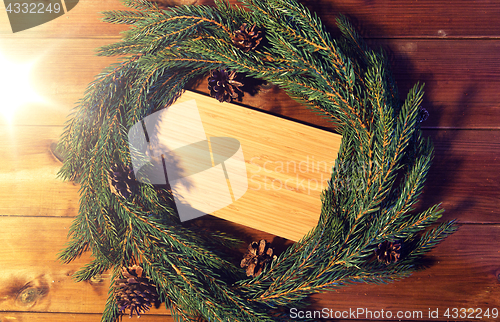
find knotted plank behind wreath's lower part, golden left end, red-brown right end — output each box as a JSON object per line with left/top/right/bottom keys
{"left": 0, "top": 217, "right": 500, "bottom": 321}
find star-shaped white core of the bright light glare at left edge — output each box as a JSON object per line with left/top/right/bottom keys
{"left": 0, "top": 54, "right": 43, "bottom": 121}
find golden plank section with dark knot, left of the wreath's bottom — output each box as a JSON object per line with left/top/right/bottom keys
{"left": 0, "top": 216, "right": 167, "bottom": 321}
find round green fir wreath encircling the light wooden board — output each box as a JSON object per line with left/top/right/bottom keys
{"left": 59, "top": 0, "right": 456, "bottom": 321}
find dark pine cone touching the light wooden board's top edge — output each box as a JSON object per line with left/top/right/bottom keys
{"left": 208, "top": 69, "right": 243, "bottom": 102}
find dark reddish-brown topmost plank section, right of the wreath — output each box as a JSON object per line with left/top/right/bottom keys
{"left": 302, "top": 0, "right": 500, "bottom": 38}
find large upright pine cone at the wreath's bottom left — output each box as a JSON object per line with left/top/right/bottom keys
{"left": 115, "top": 265, "right": 159, "bottom": 317}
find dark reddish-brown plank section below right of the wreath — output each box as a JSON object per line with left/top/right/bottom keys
{"left": 230, "top": 222, "right": 500, "bottom": 321}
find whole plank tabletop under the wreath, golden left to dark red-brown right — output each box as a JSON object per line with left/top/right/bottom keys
{"left": 0, "top": 0, "right": 500, "bottom": 322}
